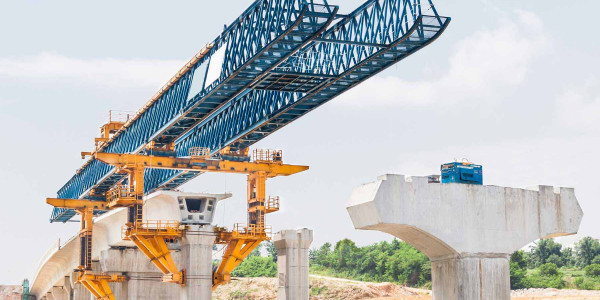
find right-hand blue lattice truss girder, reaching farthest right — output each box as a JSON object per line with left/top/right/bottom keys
{"left": 151, "top": 0, "right": 450, "bottom": 192}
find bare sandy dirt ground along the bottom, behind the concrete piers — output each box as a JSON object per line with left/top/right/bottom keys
{"left": 213, "top": 275, "right": 600, "bottom": 300}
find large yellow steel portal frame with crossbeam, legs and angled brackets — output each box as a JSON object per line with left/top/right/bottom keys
{"left": 93, "top": 152, "right": 308, "bottom": 289}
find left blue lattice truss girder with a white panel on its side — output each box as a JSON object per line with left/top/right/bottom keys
{"left": 51, "top": 0, "right": 337, "bottom": 222}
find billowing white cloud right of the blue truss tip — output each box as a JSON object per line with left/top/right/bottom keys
{"left": 338, "top": 11, "right": 548, "bottom": 107}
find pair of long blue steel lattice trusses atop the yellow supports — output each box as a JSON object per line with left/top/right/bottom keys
{"left": 51, "top": 0, "right": 450, "bottom": 222}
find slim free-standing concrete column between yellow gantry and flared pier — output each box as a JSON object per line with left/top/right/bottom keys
{"left": 273, "top": 229, "right": 313, "bottom": 300}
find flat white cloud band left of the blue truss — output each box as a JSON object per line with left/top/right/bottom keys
{"left": 0, "top": 53, "right": 185, "bottom": 88}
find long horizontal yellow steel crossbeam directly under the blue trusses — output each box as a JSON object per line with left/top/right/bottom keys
{"left": 94, "top": 152, "right": 309, "bottom": 177}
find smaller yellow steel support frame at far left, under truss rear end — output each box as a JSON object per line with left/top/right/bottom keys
{"left": 46, "top": 198, "right": 125, "bottom": 300}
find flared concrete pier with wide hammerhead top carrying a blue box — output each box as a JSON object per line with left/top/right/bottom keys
{"left": 348, "top": 175, "right": 583, "bottom": 300}
